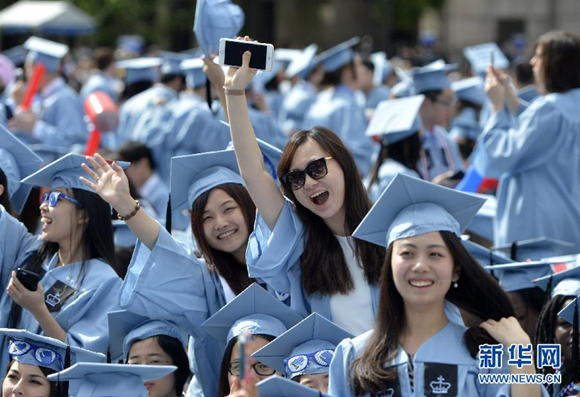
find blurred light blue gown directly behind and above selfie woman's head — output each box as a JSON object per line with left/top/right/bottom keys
{"left": 302, "top": 85, "right": 377, "bottom": 175}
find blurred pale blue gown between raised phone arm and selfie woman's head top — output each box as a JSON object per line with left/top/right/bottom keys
{"left": 279, "top": 80, "right": 318, "bottom": 133}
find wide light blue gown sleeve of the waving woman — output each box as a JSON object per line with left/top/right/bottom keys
{"left": 119, "top": 226, "right": 208, "bottom": 334}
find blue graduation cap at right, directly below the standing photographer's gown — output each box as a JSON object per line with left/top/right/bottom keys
{"left": 493, "top": 237, "right": 578, "bottom": 262}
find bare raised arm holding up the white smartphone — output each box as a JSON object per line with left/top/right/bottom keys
{"left": 224, "top": 37, "right": 284, "bottom": 230}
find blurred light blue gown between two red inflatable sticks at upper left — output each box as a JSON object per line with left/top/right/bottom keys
{"left": 34, "top": 87, "right": 88, "bottom": 147}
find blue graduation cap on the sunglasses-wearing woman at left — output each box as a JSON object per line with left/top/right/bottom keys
{"left": 22, "top": 153, "right": 129, "bottom": 193}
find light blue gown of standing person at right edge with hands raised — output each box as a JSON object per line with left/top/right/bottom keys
{"left": 473, "top": 89, "right": 580, "bottom": 245}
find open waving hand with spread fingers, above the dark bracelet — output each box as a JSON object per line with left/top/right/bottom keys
{"left": 79, "top": 153, "right": 135, "bottom": 214}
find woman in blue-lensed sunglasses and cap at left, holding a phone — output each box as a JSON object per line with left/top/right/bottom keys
{"left": 0, "top": 154, "right": 121, "bottom": 374}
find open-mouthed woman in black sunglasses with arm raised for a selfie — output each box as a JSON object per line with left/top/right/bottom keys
{"left": 225, "top": 36, "right": 384, "bottom": 335}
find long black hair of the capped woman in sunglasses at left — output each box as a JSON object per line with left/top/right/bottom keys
{"left": 10, "top": 188, "right": 118, "bottom": 328}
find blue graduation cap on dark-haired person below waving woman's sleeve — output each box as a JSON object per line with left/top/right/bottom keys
{"left": 107, "top": 310, "right": 187, "bottom": 359}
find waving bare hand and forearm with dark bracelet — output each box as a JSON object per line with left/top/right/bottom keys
{"left": 80, "top": 153, "right": 159, "bottom": 250}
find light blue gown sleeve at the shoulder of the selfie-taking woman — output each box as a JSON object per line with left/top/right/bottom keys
{"left": 246, "top": 200, "right": 304, "bottom": 294}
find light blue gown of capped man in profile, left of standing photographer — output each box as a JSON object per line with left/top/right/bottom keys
{"left": 417, "top": 125, "right": 465, "bottom": 181}
